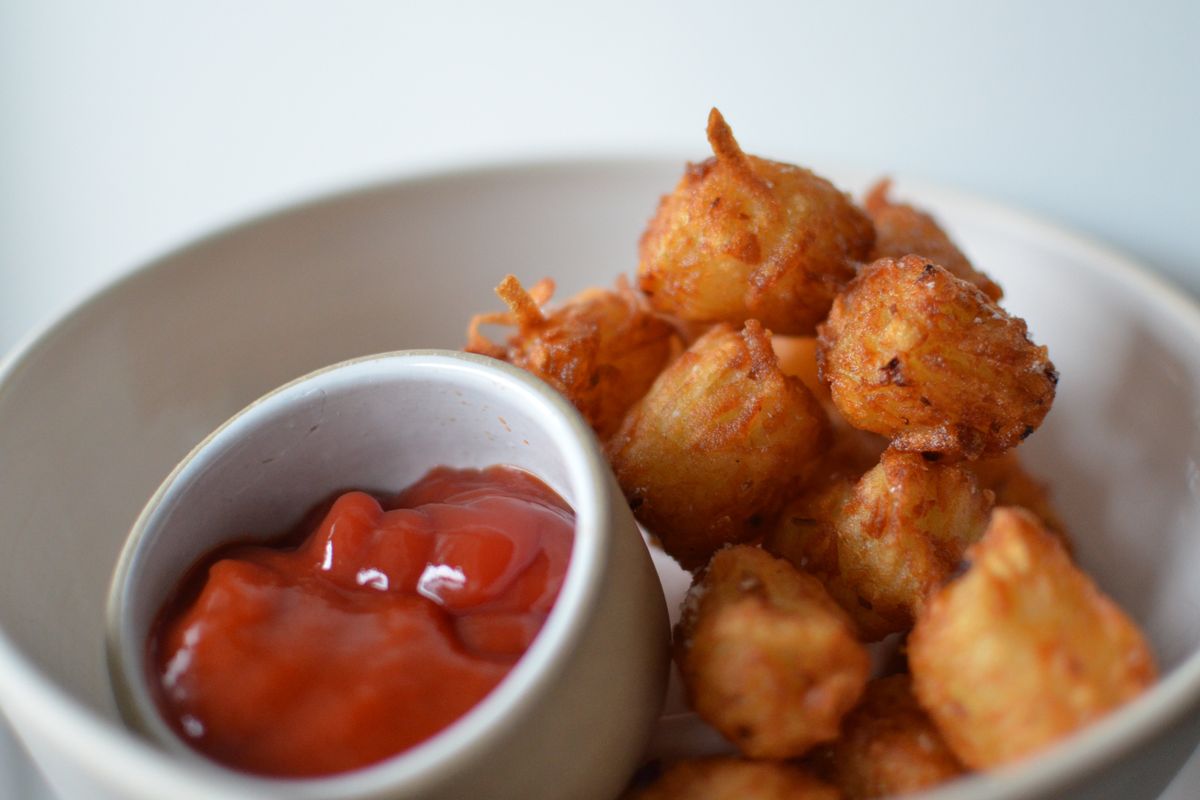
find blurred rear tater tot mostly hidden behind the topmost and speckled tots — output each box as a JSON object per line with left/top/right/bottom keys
{"left": 866, "top": 179, "right": 1004, "bottom": 302}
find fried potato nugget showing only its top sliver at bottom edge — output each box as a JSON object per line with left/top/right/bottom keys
{"left": 625, "top": 756, "right": 841, "bottom": 800}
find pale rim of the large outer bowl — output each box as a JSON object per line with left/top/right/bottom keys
{"left": 0, "top": 152, "right": 1200, "bottom": 800}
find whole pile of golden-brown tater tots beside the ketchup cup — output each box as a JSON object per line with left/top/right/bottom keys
{"left": 467, "top": 109, "right": 1156, "bottom": 800}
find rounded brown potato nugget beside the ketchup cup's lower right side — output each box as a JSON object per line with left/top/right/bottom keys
{"left": 674, "top": 545, "right": 870, "bottom": 758}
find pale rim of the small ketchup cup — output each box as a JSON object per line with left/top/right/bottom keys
{"left": 106, "top": 349, "right": 618, "bottom": 798}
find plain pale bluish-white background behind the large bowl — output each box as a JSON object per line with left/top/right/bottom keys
{"left": 0, "top": 0, "right": 1200, "bottom": 796}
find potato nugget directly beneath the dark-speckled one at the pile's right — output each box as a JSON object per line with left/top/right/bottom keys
{"left": 763, "top": 450, "right": 994, "bottom": 639}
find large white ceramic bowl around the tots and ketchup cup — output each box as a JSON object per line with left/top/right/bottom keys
{"left": 0, "top": 158, "right": 1200, "bottom": 800}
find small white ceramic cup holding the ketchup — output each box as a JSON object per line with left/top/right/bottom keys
{"left": 108, "top": 350, "right": 670, "bottom": 800}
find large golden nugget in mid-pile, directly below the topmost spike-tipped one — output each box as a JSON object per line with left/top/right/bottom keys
{"left": 608, "top": 319, "right": 829, "bottom": 570}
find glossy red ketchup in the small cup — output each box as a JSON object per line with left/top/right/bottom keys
{"left": 149, "top": 467, "right": 575, "bottom": 777}
